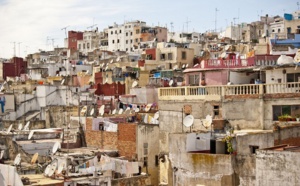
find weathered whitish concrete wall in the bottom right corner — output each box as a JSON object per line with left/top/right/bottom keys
{"left": 256, "top": 150, "right": 300, "bottom": 186}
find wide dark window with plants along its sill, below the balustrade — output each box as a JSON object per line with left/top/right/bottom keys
{"left": 273, "top": 105, "right": 300, "bottom": 121}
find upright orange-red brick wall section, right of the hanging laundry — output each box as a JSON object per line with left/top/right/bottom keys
{"left": 118, "top": 123, "right": 137, "bottom": 159}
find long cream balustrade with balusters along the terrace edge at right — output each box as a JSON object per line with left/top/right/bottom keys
{"left": 158, "top": 82, "right": 300, "bottom": 100}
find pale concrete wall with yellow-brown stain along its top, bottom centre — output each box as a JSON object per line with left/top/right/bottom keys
{"left": 169, "top": 134, "right": 235, "bottom": 186}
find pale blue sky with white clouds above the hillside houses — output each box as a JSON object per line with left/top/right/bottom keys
{"left": 0, "top": 0, "right": 299, "bottom": 58}
